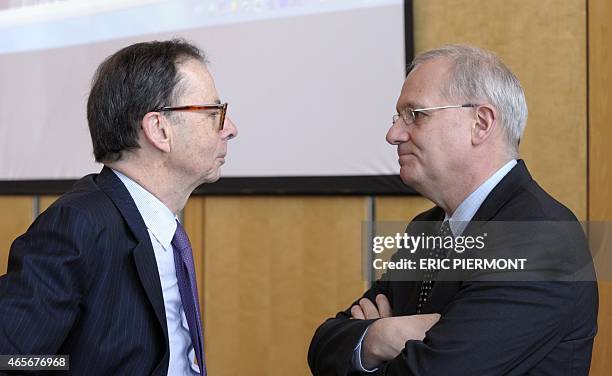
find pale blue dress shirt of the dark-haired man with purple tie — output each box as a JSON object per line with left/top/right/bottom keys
{"left": 113, "top": 170, "right": 200, "bottom": 376}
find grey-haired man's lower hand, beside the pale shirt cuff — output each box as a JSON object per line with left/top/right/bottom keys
{"left": 358, "top": 312, "right": 440, "bottom": 369}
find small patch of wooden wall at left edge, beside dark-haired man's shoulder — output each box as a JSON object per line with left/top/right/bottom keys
{"left": 0, "top": 196, "right": 32, "bottom": 275}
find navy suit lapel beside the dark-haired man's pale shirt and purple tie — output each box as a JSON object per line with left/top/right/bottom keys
{"left": 96, "top": 167, "right": 168, "bottom": 343}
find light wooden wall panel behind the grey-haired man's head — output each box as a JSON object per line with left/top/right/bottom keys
{"left": 414, "top": 0, "right": 587, "bottom": 218}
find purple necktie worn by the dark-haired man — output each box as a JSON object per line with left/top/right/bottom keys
{"left": 172, "top": 221, "right": 206, "bottom": 376}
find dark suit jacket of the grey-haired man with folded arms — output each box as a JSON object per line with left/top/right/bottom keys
{"left": 308, "top": 161, "right": 598, "bottom": 376}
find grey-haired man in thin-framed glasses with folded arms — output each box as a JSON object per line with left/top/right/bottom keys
{"left": 308, "top": 45, "right": 598, "bottom": 376}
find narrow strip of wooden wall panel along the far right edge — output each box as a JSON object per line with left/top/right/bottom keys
{"left": 588, "top": 0, "right": 612, "bottom": 376}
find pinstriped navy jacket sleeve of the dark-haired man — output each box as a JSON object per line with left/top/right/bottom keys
{"left": 0, "top": 206, "right": 100, "bottom": 355}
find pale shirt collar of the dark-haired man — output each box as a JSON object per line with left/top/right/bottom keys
{"left": 113, "top": 170, "right": 177, "bottom": 250}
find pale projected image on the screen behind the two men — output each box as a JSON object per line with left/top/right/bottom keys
{"left": 0, "top": 0, "right": 412, "bottom": 192}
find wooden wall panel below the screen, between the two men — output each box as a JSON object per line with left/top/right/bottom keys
{"left": 186, "top": 197, "right": 366, "bottom": 376}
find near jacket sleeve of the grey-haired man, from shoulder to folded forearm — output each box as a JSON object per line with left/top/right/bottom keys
{"left": 366, "top": 223, "right": 597, "bottom": 376}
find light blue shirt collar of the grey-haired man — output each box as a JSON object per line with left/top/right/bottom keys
{"left": 444, "top": 159, "right": 517, "bottom": 236}
